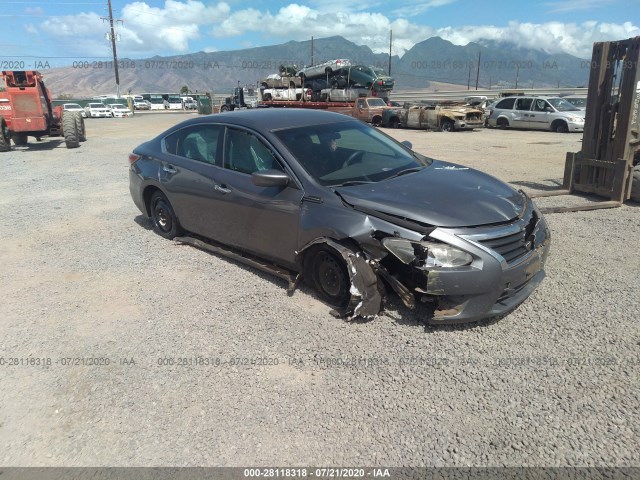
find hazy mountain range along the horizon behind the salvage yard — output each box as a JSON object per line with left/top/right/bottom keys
{"left": 37, "top": 36, "right": 590, "bottom": 98}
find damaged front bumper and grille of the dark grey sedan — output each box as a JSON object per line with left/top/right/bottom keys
{"left": 416, "top": 204, "right": 551, "bottom": 324}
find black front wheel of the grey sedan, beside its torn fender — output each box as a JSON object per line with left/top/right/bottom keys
{"left": 305, "top": 246, "right": 351, "bottom": 307}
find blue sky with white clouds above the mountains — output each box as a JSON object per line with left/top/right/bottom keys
{"left": 0, "top": 0, "right": 640, "bottom": 69}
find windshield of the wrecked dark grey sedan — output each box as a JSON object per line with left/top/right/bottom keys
{"left": 275, "top": 121, "right": 432, "bottom": 186}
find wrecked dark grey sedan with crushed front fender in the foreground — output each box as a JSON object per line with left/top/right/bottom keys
{"left": 129, "top": 109, "right": 550, "bottom": 323}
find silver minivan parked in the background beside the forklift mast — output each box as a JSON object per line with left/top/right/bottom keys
{"left": 489, "top": 96, "right": 584, "bottom": 133}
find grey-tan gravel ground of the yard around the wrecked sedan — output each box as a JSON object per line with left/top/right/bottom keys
{"left": 0, "top": 114, "right": 640, "bottom": 466}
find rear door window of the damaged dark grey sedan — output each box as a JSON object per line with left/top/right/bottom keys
{"left": 164, "top": 125, "right": 222, "bottom": 165}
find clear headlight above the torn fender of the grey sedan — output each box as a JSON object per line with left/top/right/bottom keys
{"left": 382, "top": 237, "right": 473, "bottom": 268}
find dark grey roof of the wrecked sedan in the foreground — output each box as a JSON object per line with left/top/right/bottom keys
{"left": 183, "top": 108, "right": 357, "bottom": 131}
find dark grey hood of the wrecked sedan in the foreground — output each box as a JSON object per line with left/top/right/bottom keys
{"left": 335, "top": 160, "right": 526, "bottom": 227}
